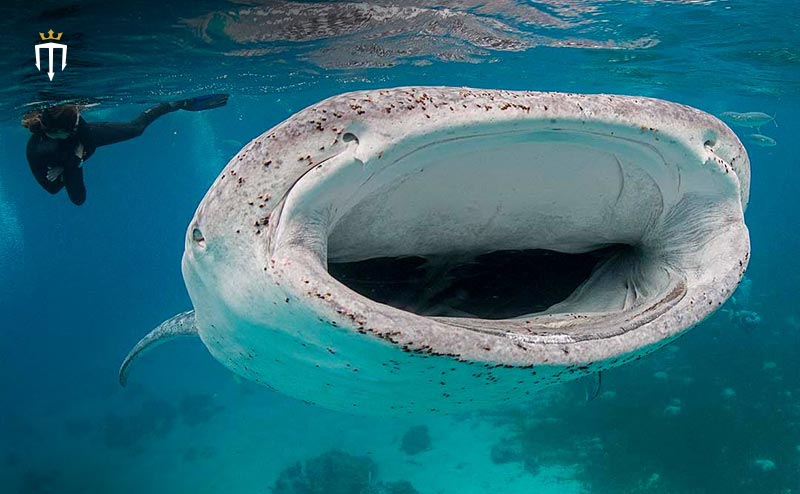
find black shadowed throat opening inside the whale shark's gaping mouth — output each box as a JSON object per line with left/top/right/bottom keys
{"left": 328, "top": 244, "right": 632, "bottom": 319}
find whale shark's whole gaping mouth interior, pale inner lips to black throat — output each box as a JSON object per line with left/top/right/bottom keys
{"left": 274, "top": 121, "right": 739, "bottom": 341}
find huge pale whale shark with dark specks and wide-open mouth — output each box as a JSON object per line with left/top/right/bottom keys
{"left": 119, "top": 87, "right": 750, "bottom": 415}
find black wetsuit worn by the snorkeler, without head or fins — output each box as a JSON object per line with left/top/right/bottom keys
{"left": 27, "top": 103, "right": 180, "bottom": 205}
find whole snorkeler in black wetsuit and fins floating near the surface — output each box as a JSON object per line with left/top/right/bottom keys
{"left": 22, "top": 94, "right": 228, "bottom": 206}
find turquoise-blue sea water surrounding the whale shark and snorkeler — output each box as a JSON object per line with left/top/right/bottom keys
{"left": 0, "top": 0, "right": 800, "bottom": 494}
